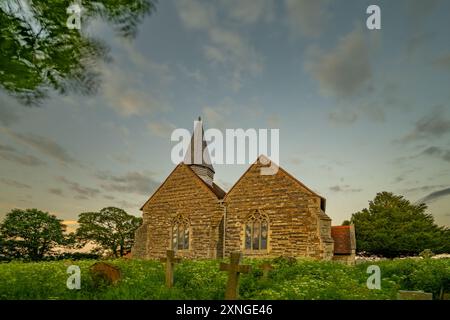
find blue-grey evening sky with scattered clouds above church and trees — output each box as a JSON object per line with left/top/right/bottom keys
{"left": 0, "top": 0, "right": 450, "bottom": 226}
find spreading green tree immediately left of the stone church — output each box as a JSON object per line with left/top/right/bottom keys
{"left": 76, "top": 207, "right": 142, "bottom": 257}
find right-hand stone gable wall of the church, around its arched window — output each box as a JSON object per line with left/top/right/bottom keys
{"left": 224, "top": 163, "right": 333, "bottom": 260}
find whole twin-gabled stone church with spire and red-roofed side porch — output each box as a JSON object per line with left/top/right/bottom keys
{"left": 132, "top": 120, "right": 355, "bottom": 263}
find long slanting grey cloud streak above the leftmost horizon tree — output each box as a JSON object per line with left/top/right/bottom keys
{"left": 5, "top": 130, "right": 78, "bottom": 164}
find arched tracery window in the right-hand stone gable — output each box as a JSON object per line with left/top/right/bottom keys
{"left": 245, "top": 210, "right": 269, "bottom": 250}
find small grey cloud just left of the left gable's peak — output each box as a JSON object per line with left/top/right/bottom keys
{"left": 96, "top": 171, "right": 160, "bottom": 196}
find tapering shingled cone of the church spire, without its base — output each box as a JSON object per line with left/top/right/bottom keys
{"left": 184, "top": 117, "right": 215, "bottom": 172}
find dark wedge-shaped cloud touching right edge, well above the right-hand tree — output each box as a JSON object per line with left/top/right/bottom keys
{"left": 400, "top": 107, "right": 450, "bottom": 142}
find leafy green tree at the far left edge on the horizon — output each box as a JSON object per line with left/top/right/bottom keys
{"left": 0, "top": 209, "right": 66, "bottom": 261}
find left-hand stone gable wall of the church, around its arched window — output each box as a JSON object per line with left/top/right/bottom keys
{"left": 133, "top": 164, "right": 223, "bottom": 259}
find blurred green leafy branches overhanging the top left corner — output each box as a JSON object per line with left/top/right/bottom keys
{"left": 0, "top": 0, "right": 155, "bottom": 105}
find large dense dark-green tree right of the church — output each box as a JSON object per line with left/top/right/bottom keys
{"left": 351, "top": 192, "right": 450, "bottom": 257}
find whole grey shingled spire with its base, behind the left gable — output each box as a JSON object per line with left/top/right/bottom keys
{"left": 184, "top": 117, "right": 214, "bottom": 186}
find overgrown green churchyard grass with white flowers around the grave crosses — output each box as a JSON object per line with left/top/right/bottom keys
{"left": 0, "top": 259, "right": 450, "bottom": 300}
